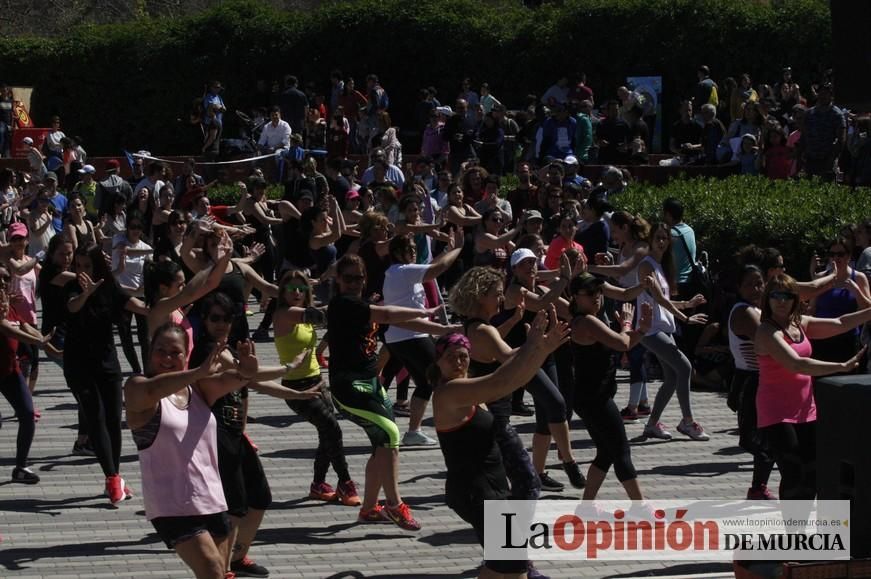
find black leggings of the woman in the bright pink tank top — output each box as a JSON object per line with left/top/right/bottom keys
{"left": 759, "top": 422, "right": 817, "bottom": 500}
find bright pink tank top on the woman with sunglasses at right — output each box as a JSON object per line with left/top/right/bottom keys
{"left": 756, "top": 331, "right": 817, "bottom": 428}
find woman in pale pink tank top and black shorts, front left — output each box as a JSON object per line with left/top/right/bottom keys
{"left": 124, "top": 323, "right": 258, "bottom": 579}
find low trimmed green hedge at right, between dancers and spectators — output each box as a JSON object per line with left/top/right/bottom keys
{"left": 615, "top": 176, "right": 871, "bottom": 279}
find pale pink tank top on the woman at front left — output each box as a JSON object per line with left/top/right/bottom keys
{"left": 139, "top": 388, "right": 227, "bottom": 521}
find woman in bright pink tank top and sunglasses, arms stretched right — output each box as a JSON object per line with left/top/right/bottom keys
{"left": 755, "top": 274, "right": 871, "bottom": 499}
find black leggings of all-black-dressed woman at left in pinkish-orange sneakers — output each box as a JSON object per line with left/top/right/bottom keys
{"left": 64, "top": 370, "right": 121, "bottom": 476}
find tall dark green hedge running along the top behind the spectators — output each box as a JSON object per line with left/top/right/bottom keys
{"left": 0, "top": 0, "right": 831, "bottom": 155}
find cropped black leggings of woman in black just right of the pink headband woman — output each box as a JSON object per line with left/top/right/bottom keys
{"left": 575, "top": 397, "right": 638, "bottom": 483}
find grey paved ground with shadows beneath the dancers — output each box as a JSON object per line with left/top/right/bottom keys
{"left": 0, "top": 308, "right": 756, "bottom": 579}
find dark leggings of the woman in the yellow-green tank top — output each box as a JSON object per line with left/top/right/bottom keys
{"left": 281, "top": 376, "right": 351, "bottom": 483}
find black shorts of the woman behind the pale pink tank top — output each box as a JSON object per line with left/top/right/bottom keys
{"left": 218, "top": 428, "right": 272, "bottom": 517}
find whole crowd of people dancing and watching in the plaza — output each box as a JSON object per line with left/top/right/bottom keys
{"left": 0, "top": 69, "right": 871, "bottom": 578}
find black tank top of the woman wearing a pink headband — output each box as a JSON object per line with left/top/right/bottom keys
{"left": 437, "top": 406, "right": 508, "bottom": 499}
